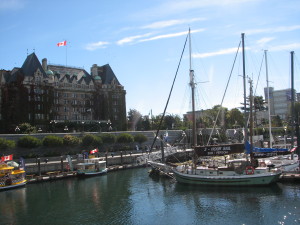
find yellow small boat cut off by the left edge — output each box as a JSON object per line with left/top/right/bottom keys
{"left": 0, "top": 161, "right": 26, "bottom": 190}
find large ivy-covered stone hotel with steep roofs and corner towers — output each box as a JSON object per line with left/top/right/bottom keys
{"left": 0, "top": 53, "right": 126, "bottom": 132}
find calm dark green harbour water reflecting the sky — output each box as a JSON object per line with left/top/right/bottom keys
{"left": 0, "top": 168, "right": 300, "bottom": 225}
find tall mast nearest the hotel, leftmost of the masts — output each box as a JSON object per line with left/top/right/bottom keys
{"left": 189, "top": 29, "right": 197, "bottom": 147}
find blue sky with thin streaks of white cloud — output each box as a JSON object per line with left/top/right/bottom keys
{"left": 0, "top": 0, "right": 300, "bottom": 116}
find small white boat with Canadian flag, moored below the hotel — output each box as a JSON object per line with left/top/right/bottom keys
{"left": 77, "top": 158, "right": 107, "bottom": 176}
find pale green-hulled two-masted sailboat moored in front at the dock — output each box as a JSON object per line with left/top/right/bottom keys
{"left": 173, "top": 31, "right": 281, "bottom": 186}
